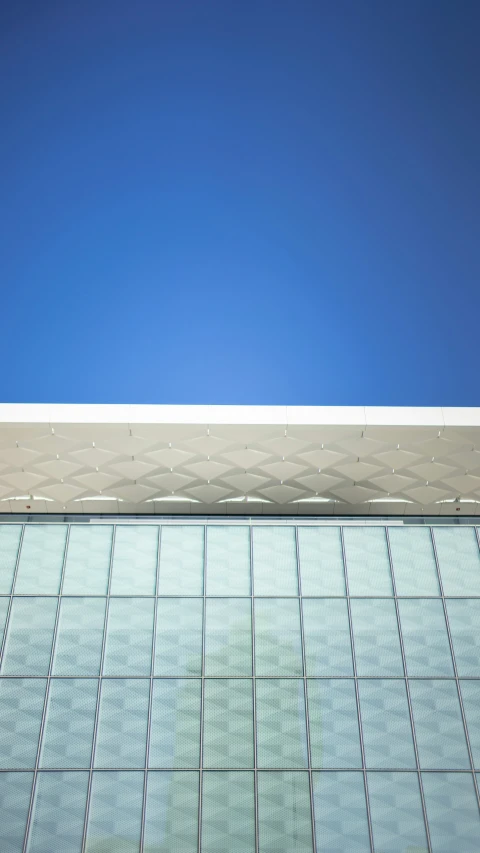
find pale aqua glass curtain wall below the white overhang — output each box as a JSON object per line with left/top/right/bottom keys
{"left": 0, "top": 515, "right": 480, "bottom": 853}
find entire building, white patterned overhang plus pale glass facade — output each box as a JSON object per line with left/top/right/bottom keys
{"left": 0, "top": 406, "right": 480, "bottom": 853}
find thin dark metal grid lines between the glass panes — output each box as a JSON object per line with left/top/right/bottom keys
{"left": 0, "top": 524, "right": 480, "bottom": 853}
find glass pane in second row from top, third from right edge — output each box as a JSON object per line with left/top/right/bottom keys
{"left": 351, "top": 598, "right": 403, "bottom": 675}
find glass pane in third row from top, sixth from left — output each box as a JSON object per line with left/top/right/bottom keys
{"left": 256, "top": 678, "right": 308, "bottom": 767}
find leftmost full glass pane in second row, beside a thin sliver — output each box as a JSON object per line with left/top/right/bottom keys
{"left": 2, "top": 598, "right": 57, "bottom": 675}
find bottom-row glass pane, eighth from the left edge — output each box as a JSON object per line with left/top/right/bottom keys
{"left": 368, "top": 773, "right": 428, "bottom": 853}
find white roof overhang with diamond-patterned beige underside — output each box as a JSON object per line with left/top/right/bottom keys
{"left": 0, "top": 404, "right": 480, "bottom": 516}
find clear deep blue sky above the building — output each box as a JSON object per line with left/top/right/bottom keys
{"left": 0, "top": 0, "right": 480, "bottom": 405}
